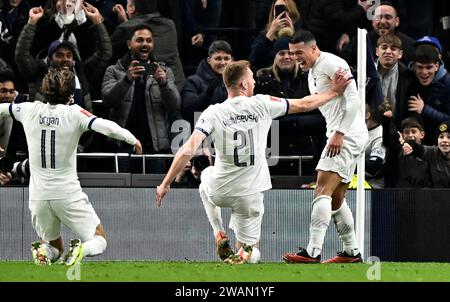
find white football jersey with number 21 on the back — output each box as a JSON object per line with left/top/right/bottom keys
{"left": 195, "top": 95, "right": 289, "bottom": 196}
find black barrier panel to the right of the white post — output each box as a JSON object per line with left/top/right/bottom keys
{"left": 371, "top": 189, "right": 450, "bottom": 262}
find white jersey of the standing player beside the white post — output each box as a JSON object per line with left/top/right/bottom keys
{"left": 308, "top": 51, "right": 367, "bottom": 137}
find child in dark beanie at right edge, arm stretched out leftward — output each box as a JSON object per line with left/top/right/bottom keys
{"left": 403, "top": 121, "right": 450, "bottom": 188}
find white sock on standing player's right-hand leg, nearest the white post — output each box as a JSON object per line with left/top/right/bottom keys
{"left": 331, "top": 199, "right": 359, "bottom": 256}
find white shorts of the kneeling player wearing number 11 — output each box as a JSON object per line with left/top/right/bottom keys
{"left": 29, "top": 193, "right": 101, "bottom": 242}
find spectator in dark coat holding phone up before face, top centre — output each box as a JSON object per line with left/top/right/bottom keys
{"left": 249, "top": 0, "right": 303, "bottom": 70}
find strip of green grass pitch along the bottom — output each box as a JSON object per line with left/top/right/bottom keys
{"left": 0, "top": 261, "right": 450, "bottom": 282}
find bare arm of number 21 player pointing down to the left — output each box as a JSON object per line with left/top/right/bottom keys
{"left": 156, "top": 130, "right": 206, "bottom": 207}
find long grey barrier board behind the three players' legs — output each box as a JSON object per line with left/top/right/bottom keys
{"left": 0, "top": 187, "right": 370, "bottom": 262}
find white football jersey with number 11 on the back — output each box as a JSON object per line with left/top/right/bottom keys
{"left": 10, "top": 101, "right": 96, "bottom": 200}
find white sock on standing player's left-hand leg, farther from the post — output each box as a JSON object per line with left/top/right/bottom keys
{"left": 306, "top": 195, "right": 331, "bottom": 258}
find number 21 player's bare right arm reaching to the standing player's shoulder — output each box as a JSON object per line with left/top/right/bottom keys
{"left": 288, "top": 69, "right": 352, "bottom": 114}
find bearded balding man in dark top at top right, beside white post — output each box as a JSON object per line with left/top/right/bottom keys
{"left": 341, "top": 1, "right": 414, "bottom": 67}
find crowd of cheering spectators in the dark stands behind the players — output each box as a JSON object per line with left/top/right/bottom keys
{"left": 0, "top": 0, "right": 450, "bottom": 188}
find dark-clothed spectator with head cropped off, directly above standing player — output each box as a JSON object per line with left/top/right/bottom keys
{"left": 307, "top": 0, "right": 372, "bottom": 54}
